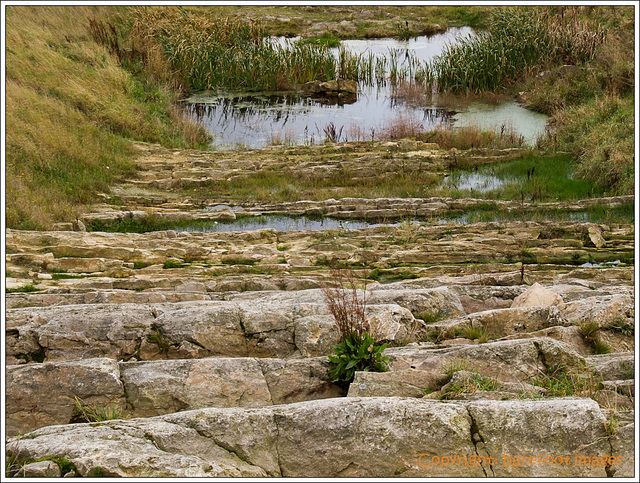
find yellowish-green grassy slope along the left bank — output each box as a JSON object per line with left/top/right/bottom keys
{"left": 5, "top": 6, "right": 208, "bottom": 229}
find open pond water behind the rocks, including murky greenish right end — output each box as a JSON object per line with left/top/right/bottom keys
{"left": 186, "top": 27, "right": 547, "bottom": 149}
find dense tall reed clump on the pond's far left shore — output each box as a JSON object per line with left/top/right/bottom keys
{"left": 132, "top": 9, "right": 340, "bottom": 90}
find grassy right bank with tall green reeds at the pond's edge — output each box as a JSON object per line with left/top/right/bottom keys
{"left": 427, "top": 6, "right": 635, "bottom": 194}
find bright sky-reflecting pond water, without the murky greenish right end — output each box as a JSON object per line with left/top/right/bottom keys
{"left": 186, "top": 27, "right": 473, "bottom": 148}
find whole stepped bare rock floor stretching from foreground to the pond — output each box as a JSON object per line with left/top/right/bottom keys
{"left": 5, "top": 143, "right": 635, "bottom": 477}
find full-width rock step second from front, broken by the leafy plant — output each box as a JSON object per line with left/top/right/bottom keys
{"left": 6, "top": 338, "right": 633, "bottom": 434}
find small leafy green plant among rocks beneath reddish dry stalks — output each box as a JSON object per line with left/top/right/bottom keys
{"left": 329, "top": 331, "right": 389, "bottom": 383}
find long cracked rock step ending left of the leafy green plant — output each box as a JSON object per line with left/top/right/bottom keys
{"left": 5, "top": 357, "right": 346, "bottom": 435}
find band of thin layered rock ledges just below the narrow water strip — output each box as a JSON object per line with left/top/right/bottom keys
{"left": 6, "top": 223, "right": 634, "bottom": 276}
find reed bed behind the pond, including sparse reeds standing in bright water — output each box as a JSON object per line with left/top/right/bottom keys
{"left": 132, "top": 9, "right": 430, "bottom": 91}
